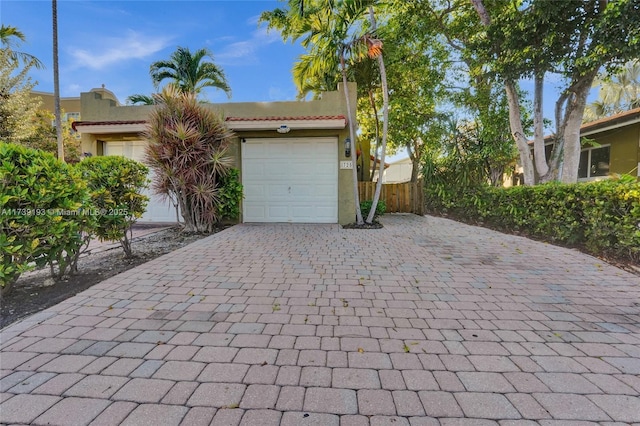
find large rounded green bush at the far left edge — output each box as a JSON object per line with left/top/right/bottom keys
{"left": 0, "top": 143, "right": 93, "bottom": 293}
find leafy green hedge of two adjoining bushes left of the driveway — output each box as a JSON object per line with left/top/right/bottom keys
{"left": 0, "top": 142, "right": 148, "bottom": 294}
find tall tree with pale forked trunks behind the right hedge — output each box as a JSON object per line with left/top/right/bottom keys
{"left": 468, "top": 0, "right": 640, "bottom": 185}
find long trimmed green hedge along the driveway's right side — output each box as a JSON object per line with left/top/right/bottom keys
{"left": 425, "top": 177, "right": 640, "bottom": 262}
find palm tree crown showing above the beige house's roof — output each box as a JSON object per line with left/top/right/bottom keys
{"left": 149, "top": 47, "right": 231, "bottom": 98}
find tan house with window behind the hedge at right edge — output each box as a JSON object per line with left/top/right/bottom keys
{"left": 545, "top": 108, "right": 640, "bottom": 182}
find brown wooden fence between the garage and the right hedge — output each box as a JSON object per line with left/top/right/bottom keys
{"left": 358, "top": 180, "right": 424, "bottom": 216}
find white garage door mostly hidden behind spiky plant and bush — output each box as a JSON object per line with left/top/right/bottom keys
{"left": 103, "top": 141, "right": 177, "bottom": 223}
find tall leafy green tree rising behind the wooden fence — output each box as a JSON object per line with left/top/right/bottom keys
{"left": 360, "top": 1, "right": 450, "bottom": 182}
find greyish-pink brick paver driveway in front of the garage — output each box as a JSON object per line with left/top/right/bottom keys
{"left": 0, "top": 215, "right": 640, "bottom": 426}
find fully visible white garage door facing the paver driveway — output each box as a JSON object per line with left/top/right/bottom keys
{"left": 242, "top": 138, "right": 338, "bottom": 223}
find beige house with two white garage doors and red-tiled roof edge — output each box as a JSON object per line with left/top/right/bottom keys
{"left": 74, "top": 83, "right": 362, "bottom": 224}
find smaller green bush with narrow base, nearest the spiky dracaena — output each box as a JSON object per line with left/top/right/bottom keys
{"left": 75, "top": 156, "right": 149, "bottom": 257}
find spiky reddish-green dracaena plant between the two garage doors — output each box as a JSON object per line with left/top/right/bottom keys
{"left": 145, "top": 85, "right": 234, "bottom": 232}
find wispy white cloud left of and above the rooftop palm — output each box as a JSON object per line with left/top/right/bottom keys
{"left": 68, "top": 30, "right": 170, "bottom": 69}
